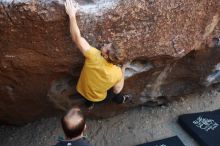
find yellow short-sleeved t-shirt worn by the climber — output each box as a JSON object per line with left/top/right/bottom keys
{"left": 76, "top": 47, "right": 122, "bottom": 102}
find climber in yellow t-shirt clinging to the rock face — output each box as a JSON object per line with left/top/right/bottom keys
{"left": 65, "top": 0, "right": 131, "bottom": 108}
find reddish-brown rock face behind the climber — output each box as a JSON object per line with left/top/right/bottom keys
{"left": 0, "top": 0, "right": 220, "bottom": 124}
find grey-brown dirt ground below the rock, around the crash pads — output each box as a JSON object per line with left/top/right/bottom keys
{"left": 0, "top": 89, "right": 220, "bottom": 146}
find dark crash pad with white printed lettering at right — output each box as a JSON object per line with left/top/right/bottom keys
{"left": 178, "top": 110, "right": 220, "bottom": 146}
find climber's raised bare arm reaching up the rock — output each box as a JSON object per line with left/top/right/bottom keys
{"left": 65, "top": 0, "right": 91, "bottom": 54}
